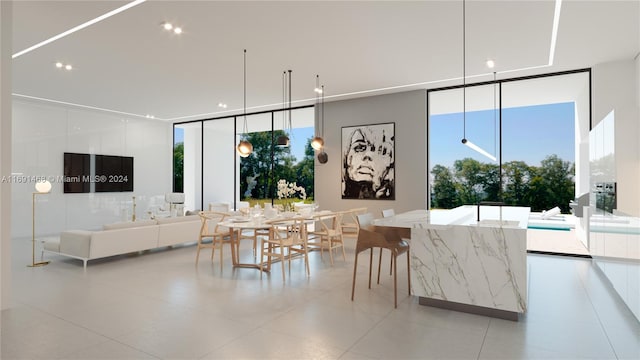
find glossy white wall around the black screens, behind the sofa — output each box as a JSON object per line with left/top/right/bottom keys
{"left": 11, "top": 100, "right": 172, "bottom": 237}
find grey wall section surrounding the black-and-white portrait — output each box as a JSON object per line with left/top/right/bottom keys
{"left": 314, "top": 90, "right": 427, "bottom": 217}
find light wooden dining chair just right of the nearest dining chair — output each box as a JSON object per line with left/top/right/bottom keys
{"left": 308, "top": 212, "right": 347, "bottom": 265}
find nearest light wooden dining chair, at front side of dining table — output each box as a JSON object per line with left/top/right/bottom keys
{"left": 260, "top": 218, "right": 311, "bottom": 282}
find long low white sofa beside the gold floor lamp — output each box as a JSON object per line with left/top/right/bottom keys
{"left": 43, "top": 215, "right": 201, "bottom": 269}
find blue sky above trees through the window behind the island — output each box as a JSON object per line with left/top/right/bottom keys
{"left": 429, "top": 102, "right": 575, "bottom": 167}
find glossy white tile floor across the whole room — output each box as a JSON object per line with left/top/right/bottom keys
{"left": 1, "top": 235, "right": 640, "bottom": 359}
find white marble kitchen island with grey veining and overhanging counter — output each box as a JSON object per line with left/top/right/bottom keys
{"left": 374, "top": 205, "right": 530, "bottom": 320}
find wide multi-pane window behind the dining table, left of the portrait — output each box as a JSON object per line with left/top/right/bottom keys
{"left": 173, "top": 107, "right": 314, "bottom": 210}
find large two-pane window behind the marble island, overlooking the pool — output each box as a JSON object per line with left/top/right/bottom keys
{"left": 429, "top": 72, "right": 588, "bottom": 213}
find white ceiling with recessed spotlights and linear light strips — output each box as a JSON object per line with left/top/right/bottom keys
{"left": 13, "top": 0, "right": 640, "bottom": 121}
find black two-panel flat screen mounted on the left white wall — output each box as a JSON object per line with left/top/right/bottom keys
{"left": 63, "top": 153, "right": 133, "bottom": 193}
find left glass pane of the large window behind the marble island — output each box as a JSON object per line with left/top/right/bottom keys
{"left": 429, "top": 86, "right": 500, "bottom": 209}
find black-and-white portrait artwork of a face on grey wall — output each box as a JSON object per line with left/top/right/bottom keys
{"left": 342, "top": 123, "right": 395, "bottom": 200}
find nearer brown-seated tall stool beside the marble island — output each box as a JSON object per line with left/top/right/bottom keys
{"left": 351, "top": 213, "right": 411, "bottom": 308}
